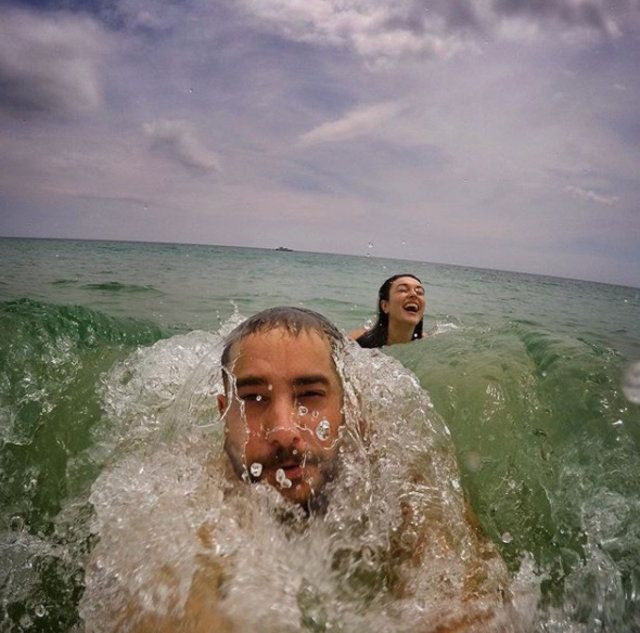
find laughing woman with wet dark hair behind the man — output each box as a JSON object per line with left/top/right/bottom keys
{"left": 349, "top": 273, "right": 426, "bottom": 347}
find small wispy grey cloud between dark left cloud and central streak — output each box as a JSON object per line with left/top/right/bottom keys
{"left": 143, "top": 119, "right": 221, "bottom": 171}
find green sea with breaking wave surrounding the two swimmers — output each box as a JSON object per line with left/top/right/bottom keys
{"left": 0, "top": 238, "right": 640, "bottom": 633}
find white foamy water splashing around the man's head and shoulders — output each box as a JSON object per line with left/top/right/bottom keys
{"left": 81, "top": 328, "right": 537, "bottom": 633}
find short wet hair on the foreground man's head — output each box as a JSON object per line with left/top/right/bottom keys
{"left": 220, "top": 306, "right": 344, "bottom": 389}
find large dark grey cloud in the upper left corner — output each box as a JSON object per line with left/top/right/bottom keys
{"left": 0, "top": 9, "right": 108, "bottom": 117}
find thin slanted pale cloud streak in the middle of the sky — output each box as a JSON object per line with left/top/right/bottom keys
{"left": 300, "top": 103, "right": 400, "bottom": 145}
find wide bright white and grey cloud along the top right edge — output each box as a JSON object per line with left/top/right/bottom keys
{"left": 240, "top": 0, "right": 640, "bottom": 66}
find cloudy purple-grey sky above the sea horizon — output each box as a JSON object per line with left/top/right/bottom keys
{"left": 0, "top": 0, "right": 640, "bottom": 286}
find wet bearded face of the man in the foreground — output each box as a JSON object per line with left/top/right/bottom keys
{"left": 218, "top": 328, "right": 343, "bottom": 504}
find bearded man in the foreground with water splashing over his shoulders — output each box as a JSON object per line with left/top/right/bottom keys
{"left": 84, "top": 308, "right": 516, "bottom": 633}
